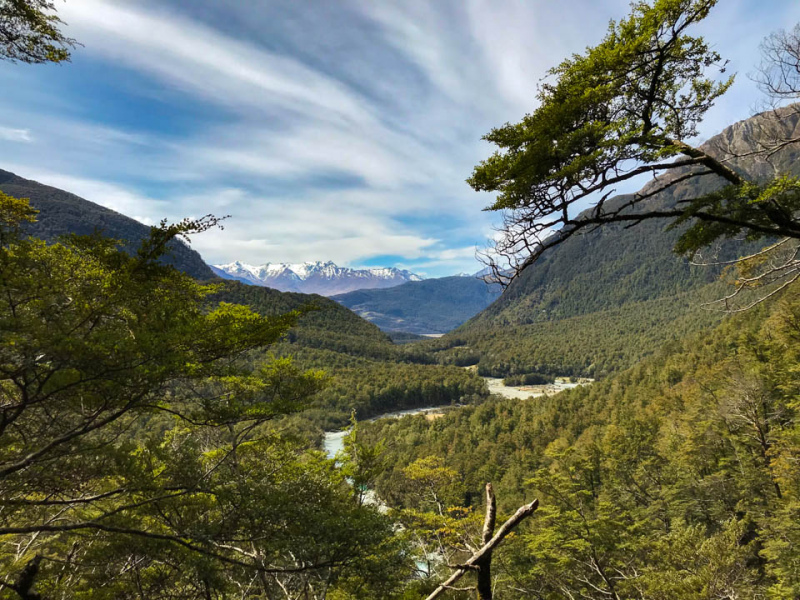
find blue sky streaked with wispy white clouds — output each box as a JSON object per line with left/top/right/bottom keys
{"left": 0, "top": 0, "right": 800, "bottom": 277}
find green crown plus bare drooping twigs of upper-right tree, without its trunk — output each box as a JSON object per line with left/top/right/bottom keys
{"left": 468, "top": 0, "right": 752, "bottom": 282}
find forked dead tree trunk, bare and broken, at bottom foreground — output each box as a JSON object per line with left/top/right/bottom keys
{"left": 425, "top": 483, "right": 539, "bottom": 600}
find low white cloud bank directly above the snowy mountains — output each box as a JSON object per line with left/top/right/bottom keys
{"left": 4, "top": 164, "right": 440, "bottom": 265}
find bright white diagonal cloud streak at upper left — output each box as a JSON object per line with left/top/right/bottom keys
{"left": 62, "top": 0, "right": 376, "bottom": 123}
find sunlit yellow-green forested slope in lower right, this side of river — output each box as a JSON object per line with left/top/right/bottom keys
{"left": 361, "top": 286, "right": 800, "bottom": 599}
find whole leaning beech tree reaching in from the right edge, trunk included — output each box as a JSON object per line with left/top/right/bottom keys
{"left": 468, "top": 0, "right": 800, "bottom": 308}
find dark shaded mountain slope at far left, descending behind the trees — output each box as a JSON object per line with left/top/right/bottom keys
{"left": 0, "top": 169, "right": 214, "bottom": 279}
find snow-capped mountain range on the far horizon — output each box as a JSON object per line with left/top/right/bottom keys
{"left": 211, "top": 260, "right": 422, "bottom": 296}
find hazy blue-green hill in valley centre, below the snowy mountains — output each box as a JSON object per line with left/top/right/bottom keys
{"left": 333, "top": 277, "right": 501, "bottom": 333}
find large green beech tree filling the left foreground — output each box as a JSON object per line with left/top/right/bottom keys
{"left": 0, "top": 193, "right": 405, "bottom": 599}
